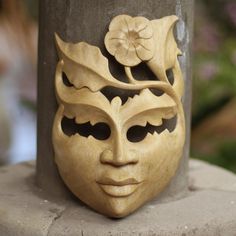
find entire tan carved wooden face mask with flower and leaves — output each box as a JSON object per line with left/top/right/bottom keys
{"left": 53, "top": 15, "right": 185, "bottom": 217}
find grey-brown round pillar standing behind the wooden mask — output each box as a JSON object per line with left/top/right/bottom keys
{"left": 37, "top": 0, "right": 193, "bottom": 199}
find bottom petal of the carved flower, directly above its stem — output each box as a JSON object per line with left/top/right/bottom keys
{"left": 115, "top": 45, "right": 141, "bottom": 66}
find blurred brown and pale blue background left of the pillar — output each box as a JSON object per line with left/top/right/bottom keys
{"left": 0, "top": 0, "right": 37, "bottom": 164}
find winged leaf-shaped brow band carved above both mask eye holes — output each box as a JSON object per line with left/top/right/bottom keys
{"left": 55, "top": 60, "right": 176, "bottom": 129}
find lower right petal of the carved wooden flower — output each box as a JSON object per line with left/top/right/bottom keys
{"left": 136, "top": 38, "right": 155, "bottom": 61}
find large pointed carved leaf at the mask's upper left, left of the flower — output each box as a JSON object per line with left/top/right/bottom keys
{"left": 55, "top": 34, "right": 119, "bottom": 91}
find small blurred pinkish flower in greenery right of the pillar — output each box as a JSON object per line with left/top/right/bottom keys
{"left": 198, "top": 61, "right": 219, "bottom": 80}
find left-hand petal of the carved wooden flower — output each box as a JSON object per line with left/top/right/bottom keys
{"left": 104, "top": 31, "right": 126, "bottom": 55}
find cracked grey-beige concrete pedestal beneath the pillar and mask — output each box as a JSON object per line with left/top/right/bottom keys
{"left": 0, "top": 160, "right": 236, "bottom": 236}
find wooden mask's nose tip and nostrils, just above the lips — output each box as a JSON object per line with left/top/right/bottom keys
{"left": 100, "top": 138, "right": 138, "bottom": 167}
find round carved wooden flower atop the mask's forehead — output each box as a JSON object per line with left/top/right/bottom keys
{"left": 105, "top": 15, "right": 154, "bottom": 66}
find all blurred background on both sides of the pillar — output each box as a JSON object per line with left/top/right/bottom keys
{"left": 0, "top": 0, "right": 236, "bottom": 173}
